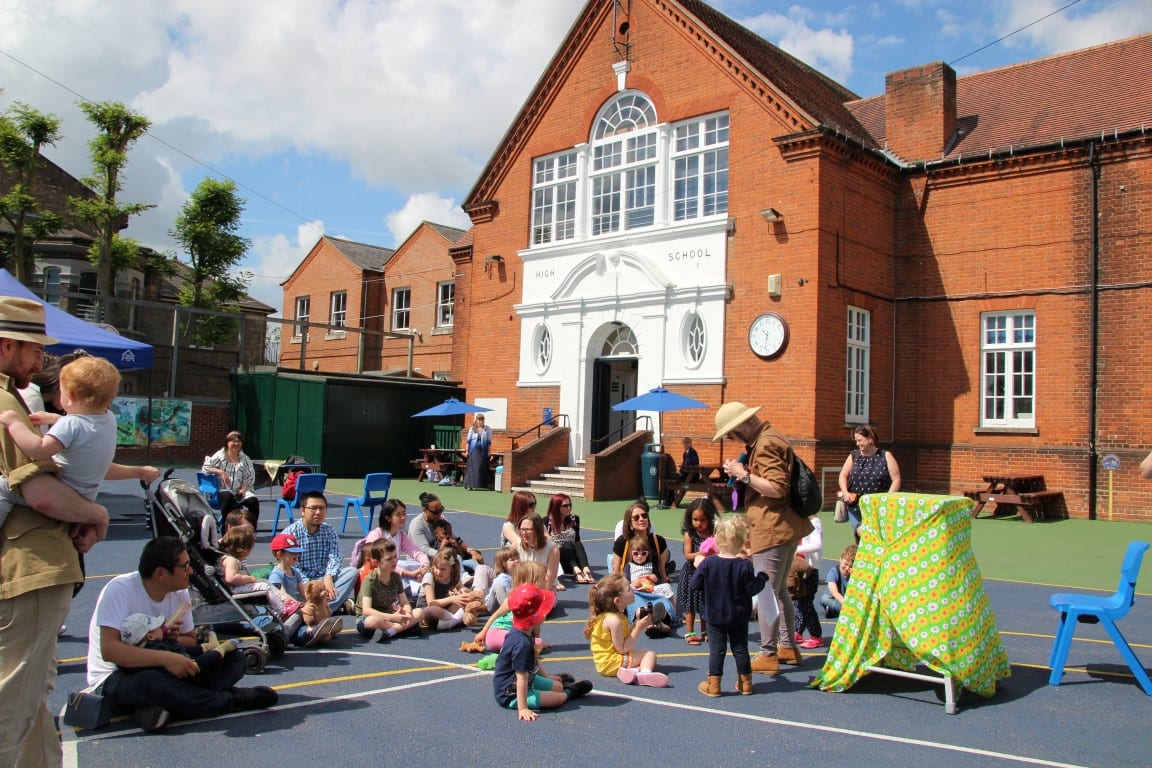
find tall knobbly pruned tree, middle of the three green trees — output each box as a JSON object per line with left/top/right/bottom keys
{"left": 69, "top": 101, "right": 156, "bottom": 296}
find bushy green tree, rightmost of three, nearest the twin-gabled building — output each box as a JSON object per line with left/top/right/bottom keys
{"left": 169, "top": 178, "right": 250, "bottom": 345}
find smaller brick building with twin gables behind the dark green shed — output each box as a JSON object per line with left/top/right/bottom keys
{"left": 280, "top": 221, "right": 465, "bottom": 379}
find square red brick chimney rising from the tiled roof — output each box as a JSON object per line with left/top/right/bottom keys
{"left": 884, "top": 61, "right": 956, "bottom": 162}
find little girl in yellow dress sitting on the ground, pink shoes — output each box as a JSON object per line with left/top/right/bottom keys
{"left": 584, "top": 573, "right": 668, "bottom": 689}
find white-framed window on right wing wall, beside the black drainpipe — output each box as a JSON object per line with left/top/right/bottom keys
{"left": 980, "top": 310, "right": 1036, "bottom": 429}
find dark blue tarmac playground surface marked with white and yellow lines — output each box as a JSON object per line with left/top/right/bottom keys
{"left": 50, "top": 471, "right": 1152, "bottom": 768}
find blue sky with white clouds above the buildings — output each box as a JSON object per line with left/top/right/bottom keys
{"left": 0, "top": 0, "right": 1152, "bottom": 309}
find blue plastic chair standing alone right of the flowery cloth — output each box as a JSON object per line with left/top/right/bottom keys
{"left": 1048, "top": 541, "right": 1152, "bottom": 695}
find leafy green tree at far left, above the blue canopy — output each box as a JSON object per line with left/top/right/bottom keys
{"left": 0, "top": 101, "right": 63, "bottom": 286}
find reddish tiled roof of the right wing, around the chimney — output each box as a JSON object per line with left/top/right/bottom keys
{"left": 847, "top": 35, "right": 1152, "bottom": 161}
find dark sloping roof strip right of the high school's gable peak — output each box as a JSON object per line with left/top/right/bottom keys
{"left": 679, "top": 0, "right": 871, "bottom": 143}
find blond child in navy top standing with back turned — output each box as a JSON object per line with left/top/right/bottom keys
{"left": 691, "top": 515, "right": 768, "bottom": 698}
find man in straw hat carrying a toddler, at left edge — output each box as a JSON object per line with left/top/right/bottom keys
{"left": 0, "top": 296, "right": 108, "bottom": 768}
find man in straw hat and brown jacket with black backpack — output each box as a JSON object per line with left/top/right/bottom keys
{"left": 712, "top": 401, "right": 812, "bottom": 675}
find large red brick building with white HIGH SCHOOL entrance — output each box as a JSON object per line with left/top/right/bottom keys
{"left": 453, "top": 0, "right": 1152, "bottom": 519}
